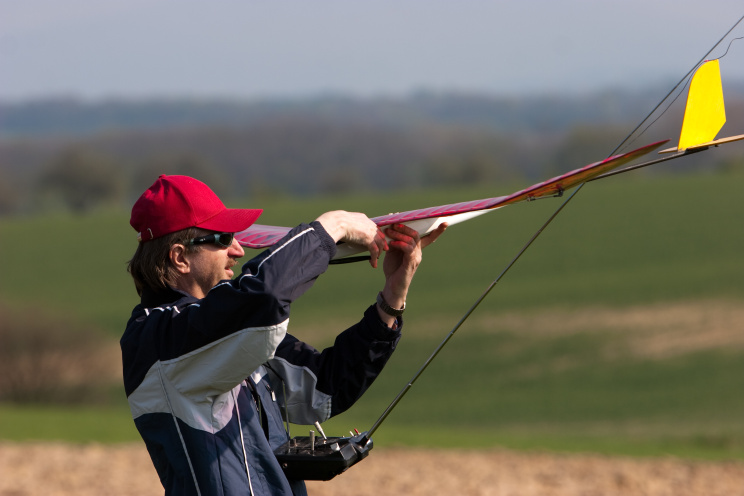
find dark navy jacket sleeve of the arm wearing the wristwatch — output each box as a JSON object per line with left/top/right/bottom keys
{"left": 267, "top": 305, "right": 402, "bottom": 424}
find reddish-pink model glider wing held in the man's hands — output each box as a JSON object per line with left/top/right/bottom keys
{"left": 235, "top": 140, "right": 668, "bottom": 248}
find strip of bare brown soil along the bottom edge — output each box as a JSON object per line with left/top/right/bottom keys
{"left": 0, "top": 443, "right": 744, "bottom": 496}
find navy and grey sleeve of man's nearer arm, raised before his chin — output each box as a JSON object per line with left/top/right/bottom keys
{"left": 122, "top": 223, "right": 335, "bottom": 397}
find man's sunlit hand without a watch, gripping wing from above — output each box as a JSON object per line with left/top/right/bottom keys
{"left": 315, "top": 210, "right": 388, "bottom": 268}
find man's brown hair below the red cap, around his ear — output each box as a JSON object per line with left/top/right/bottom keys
{"left": 127, "top": 227, "right": 203, "bottom": 296}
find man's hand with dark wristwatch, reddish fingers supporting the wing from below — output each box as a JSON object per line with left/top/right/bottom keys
{"left": 377, "top": 223, "right": 447, "bottom": 326}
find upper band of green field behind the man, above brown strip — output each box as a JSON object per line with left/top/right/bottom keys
{"left": 0, "top": 170, "right": 744, "bottom": 335}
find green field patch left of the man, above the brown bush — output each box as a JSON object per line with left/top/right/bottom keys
{"left": 0, "top": 207, "right": 137, "bottom": 336}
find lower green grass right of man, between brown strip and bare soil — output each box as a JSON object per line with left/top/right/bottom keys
{"left": 316, "top": 332, "right": 744, "bottom": 459}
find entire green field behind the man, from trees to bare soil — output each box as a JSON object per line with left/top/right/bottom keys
{"left": 0, "top": 170, "right": 744, "bottom": 458}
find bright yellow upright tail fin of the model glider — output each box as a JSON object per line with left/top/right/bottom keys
{"left": 677, "top": 60, "right": 726, "bottom": 150}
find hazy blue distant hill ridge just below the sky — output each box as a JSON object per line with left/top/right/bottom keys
{"left": 0, "top": 89, "right": 692, "bottom": 138}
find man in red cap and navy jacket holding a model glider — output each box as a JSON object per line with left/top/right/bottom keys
{"left": 121, "top": 176, "right": 444, "bottom": 495}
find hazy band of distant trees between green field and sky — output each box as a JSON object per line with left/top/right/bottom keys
{"left": 0, "top": 89, "right": 744, "bottom": 215}
